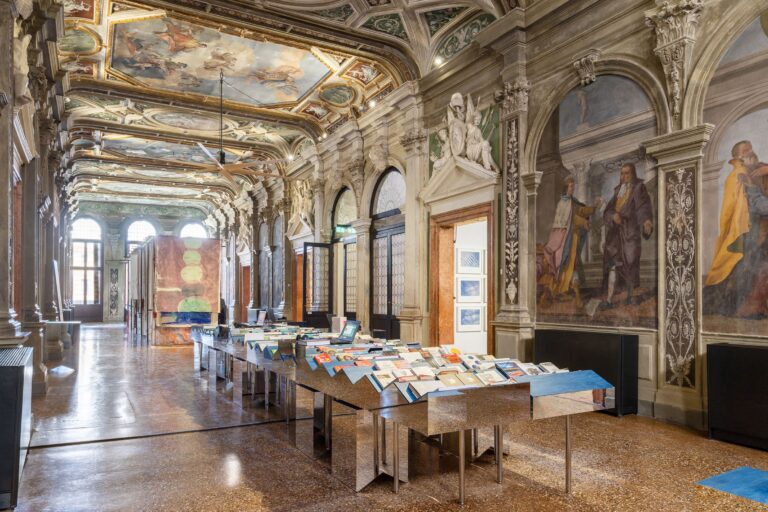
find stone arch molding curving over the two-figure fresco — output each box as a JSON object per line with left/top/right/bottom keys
{"left": 522, "top": 55, "right": 671, "bottom": 176}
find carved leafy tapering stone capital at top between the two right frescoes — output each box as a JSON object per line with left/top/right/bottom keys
{"left": 645, "top": 0, "right": 704, "bottom": 121}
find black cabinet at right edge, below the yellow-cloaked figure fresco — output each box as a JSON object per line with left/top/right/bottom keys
{"left": 707, "top": 343, "right": 768, "bottom": 450}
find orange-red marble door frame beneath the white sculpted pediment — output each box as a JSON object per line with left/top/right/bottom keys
{"left": 429, "top": 202, "right": 496, "bottom": 354}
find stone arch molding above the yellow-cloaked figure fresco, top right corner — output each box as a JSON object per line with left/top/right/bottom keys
{"left": 682, "top": 0, "right": 768, "bottom": 128}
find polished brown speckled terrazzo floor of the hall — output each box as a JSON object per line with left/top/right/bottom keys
{"left": 18, "top": 328, "right": 768, "bottom": 512}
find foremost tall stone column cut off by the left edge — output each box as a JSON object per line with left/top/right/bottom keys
{"left": 0, "top": 0, "right": 28, "bottom": 345}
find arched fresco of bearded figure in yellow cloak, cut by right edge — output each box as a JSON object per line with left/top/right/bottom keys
{"left": 702, "top": 14, "right": 768, "bottom": 336}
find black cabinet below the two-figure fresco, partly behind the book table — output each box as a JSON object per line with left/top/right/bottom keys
{"left": 533, "top": 329, "right": 639, "bottom": 416}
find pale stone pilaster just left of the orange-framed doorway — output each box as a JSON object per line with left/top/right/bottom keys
{"left": 398, "top": 128, "right": 429, "bottom": 341}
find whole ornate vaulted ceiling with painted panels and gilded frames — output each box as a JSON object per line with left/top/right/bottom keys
{"left": 58, "top": 0, "right": 504, "bottom": 216}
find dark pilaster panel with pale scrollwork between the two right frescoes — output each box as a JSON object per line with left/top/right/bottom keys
{"left": 664, "top": 168, "right": 698, "bottom": 388}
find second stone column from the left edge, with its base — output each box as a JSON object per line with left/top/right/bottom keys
{"left": 20, "top": 158, "right": 48, "bottom": 395}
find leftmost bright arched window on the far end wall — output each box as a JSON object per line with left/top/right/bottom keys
{"left": 71, "top": 218, "right": 102, "bottom": 304}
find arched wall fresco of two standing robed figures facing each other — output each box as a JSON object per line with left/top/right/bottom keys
{"left": 536, "top": 75, "right": 658, "bottom": 328}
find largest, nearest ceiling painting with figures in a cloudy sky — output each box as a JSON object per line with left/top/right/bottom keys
{"left": 110, "top": 18, "right": 329, "bottom": 105}
